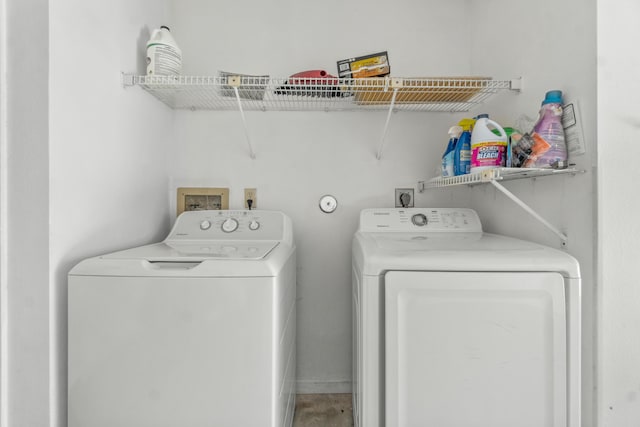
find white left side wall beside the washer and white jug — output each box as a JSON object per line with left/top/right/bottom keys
{"left": 47, "top": 0, "right": 173, "bottom": 427}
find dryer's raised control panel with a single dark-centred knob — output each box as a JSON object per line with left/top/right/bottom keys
{"left": 358, "top": 208, "right": 482, "bottom": 233}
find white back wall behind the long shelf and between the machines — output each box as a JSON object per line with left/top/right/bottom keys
{"left": 169, "top": 0, "right": 469, "bottom": 392}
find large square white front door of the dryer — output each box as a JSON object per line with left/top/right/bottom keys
{"left": 385, "top": 271, "right": 567, "bottom": 427}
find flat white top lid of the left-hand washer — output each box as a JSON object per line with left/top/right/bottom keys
{"left": 102, "top": 240, "right": 279, "bottom": 262}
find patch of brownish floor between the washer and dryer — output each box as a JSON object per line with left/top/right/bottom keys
{"left": 293, "top": 394, "right": 353, "bottom": 427}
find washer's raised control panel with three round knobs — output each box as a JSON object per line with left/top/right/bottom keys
{"left": 167, "top": 210, "right": 285, "bottom": 240}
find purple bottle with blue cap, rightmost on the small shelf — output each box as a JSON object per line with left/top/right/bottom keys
{"left": 525, "top": 90, "right": 567, "bottom": 169}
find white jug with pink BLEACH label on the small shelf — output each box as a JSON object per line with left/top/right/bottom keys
{"left": 471, "top": 118, "right": 507, "bottom": 173}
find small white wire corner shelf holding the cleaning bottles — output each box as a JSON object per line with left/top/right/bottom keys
{"left": 418, "top": 168, "right": 584, "bottom": 192}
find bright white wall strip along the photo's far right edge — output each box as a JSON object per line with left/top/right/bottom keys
{"left": 597, "top": 0, "right": 640, "bottom": 427}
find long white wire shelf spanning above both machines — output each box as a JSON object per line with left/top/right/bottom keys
{"left": 123, "top": 74, "right": 521, "bottom": 112}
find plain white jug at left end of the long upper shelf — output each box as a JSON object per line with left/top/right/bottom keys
{"left": 147, "top": 25, "right": 182, "bottom": 76}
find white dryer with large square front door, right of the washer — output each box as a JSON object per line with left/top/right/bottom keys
{"left": 353, "top": 209, "right": 580, "bottom": 427}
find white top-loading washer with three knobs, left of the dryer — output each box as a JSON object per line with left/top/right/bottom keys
{"left": 68, "top": 211, "right": 296, "bottom": 427}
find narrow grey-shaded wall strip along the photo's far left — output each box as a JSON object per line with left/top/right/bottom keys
{"left": 3, "top": 0, "right": 49, "bottom": 426}
